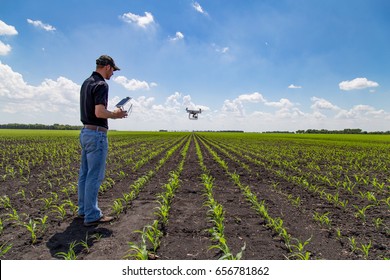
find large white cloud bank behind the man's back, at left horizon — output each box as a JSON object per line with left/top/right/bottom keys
{"left": 0, "top": 63, "right": 80, "bottom": 124}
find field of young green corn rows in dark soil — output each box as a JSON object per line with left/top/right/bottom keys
{"left": 0, "top": 130, "right": 390, "bottom": 260}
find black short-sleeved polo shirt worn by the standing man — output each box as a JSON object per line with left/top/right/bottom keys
{"left": 80, "top": 72, "right": 108, "bottom": 129}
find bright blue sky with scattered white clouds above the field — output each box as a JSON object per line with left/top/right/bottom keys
{"left": 0, "top": 0, "right": 390, "bottom": 131}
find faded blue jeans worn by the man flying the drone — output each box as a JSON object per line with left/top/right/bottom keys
{"left": 78, "top": 128, "right": 108, "bottom": 223}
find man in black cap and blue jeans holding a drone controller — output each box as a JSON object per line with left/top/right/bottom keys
{"left": 78, "top": 55, "right": 127, "bottom": 226}
